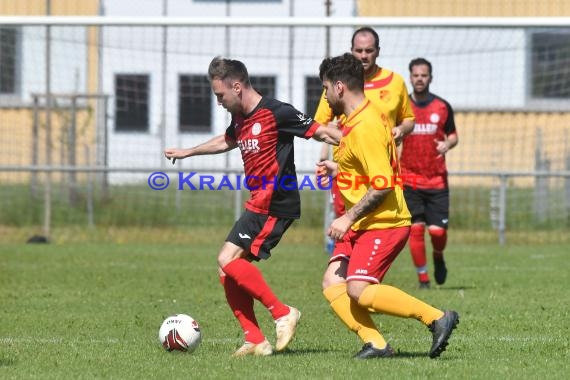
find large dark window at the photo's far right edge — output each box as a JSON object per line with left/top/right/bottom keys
{"left": 531, "top": 29, "right": 570, "bottom": 99}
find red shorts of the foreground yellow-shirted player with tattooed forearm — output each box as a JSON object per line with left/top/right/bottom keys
{"left": 329, "top": 227, "right": 410, "bottom": 284}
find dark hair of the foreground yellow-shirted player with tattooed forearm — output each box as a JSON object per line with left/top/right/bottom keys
{"left": 319, "top": 53, "right": 364, "bottom": 91}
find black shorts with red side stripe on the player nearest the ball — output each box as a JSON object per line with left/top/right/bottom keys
{"left": 226, "top": 210, "right": 294, "bottom": 261}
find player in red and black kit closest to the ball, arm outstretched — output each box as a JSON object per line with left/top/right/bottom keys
{"left": 164, "top": 57, "right": 342, "bottom": 356}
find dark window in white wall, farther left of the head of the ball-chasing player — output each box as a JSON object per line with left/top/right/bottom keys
{"left": 115, "top": 74, "right": 149, "bottom": 132}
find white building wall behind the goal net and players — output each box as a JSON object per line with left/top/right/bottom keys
{"left": 92, "top": 0, "right": 527, "bottom": 179}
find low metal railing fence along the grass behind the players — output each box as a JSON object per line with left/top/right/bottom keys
{"left": 0, "top": 166, "right": 570, "bottom": 245}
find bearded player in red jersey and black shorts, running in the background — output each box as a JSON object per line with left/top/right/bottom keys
{"left": 400, "top": 58, "right": 458, "bottom": 288}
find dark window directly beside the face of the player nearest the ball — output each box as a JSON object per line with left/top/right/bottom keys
{"left": 178, "top": 75, "right": 212, "bottom": 132}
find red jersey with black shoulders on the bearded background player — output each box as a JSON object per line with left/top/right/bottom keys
{"left": 400, "top": 94, "right": 457, "bottom": 189}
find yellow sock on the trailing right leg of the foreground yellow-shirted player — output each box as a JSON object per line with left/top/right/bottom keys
{"left": 356, "top": 284, "right": 443, "bottom": 326}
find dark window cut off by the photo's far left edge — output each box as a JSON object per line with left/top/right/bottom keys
{"left": 0, "top": 28, "right": 18, "bottom": 95}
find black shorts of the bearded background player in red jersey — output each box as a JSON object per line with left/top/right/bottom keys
{"left": 404, "top": 186, "right": 449, "bottom": 229}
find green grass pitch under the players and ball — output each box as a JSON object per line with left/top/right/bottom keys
{"left": 0, "top": 230, "right": 570, "bottom": 379}
